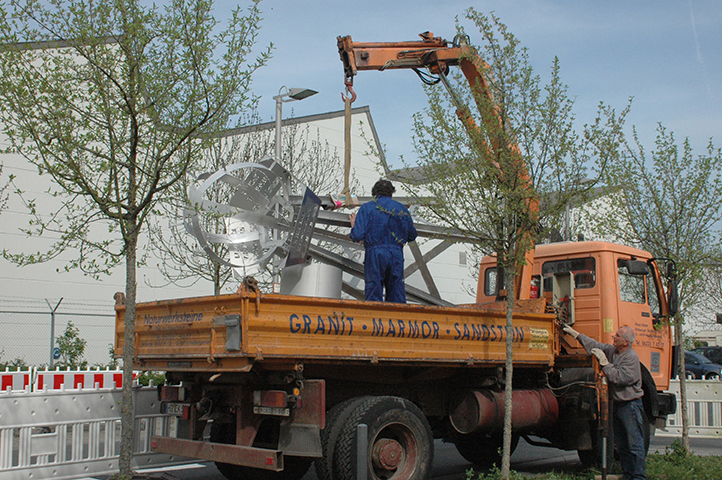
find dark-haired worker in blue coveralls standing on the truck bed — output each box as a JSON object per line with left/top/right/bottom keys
{"left": 350, "top": 180, "right": 416, "bottom": 303}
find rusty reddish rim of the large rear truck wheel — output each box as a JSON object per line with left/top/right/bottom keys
{"left": 370, "top": 423, "right": 419, "bottom": 480}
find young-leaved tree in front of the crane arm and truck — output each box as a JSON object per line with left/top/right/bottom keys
{"left": 406, "top": 8, "right": 627, "bottom": 478}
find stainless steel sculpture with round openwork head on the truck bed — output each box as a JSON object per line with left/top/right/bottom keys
{"left": 184, "top": 157, "right": 468, "bottom": 305}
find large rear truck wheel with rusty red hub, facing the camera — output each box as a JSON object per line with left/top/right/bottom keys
{"left": 333, "top": 397, "right": 434, "bottom": 480}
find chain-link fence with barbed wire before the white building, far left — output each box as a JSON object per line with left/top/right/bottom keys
{"left": 0, "top": 297, "right": 115, "bottom": 366}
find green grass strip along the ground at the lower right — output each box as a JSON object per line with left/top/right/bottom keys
{"left": 466, "top": 440, "right": 722, "bottom": 480}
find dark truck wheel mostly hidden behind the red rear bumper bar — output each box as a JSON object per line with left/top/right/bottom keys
{"left": 211, "top": 422, "right": 313, "bottom": 480}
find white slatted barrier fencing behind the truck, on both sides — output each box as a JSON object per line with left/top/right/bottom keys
{"left": 0, "top": 369, "right": 722, "bottom": 480}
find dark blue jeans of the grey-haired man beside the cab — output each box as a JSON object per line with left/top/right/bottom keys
{"left": 614, "top": 398, "right": 647, "bottom": 480}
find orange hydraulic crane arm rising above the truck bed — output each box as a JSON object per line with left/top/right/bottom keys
{"left": 337, "top": 32, "right": 539, "bottom": 299}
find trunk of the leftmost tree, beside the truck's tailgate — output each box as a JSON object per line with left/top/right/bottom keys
{"left": 118, "top": 228, "right": 138, "bottom": 479}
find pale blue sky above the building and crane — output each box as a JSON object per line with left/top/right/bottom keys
{"left": 243, "top": 0, "right": 722, "bottom": 165}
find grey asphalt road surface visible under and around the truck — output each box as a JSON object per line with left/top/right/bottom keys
{"left": 126, "top": 437, "right": 722, "bottom": 480}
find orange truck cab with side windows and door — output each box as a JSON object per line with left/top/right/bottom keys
{"left": 477, "top": 242, "right": 676, "bottom": 425}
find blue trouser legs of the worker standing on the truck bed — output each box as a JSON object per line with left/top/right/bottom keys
{"left": 364, "top": 245, "right": 406, "bottom": 303}
